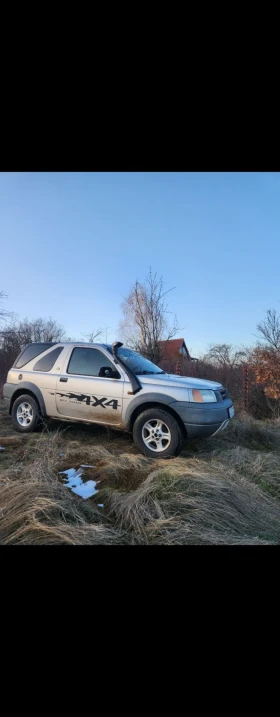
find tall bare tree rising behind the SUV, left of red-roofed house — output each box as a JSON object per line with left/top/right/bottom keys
{"left": 120, "top": 269, "right": 182, "bottom": 361}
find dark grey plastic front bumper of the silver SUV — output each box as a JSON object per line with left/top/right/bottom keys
{"left": 170, "top": 398, "right": 233, "bottom": 438}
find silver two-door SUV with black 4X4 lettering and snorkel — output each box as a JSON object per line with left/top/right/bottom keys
{"left": 3, "top": 342, "right": 234, "bottom": 458}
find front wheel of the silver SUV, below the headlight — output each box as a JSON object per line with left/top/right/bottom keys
{"left": 133, "top": 408, "right": 184, "bottom": 458}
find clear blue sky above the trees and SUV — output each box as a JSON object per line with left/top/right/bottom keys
{"left": 0, "top": 172, "right": 280, "bottom": 356}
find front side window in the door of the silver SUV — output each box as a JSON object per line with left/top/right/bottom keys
{"left": 67, "top": 347, "right": 120, "bottom": 378}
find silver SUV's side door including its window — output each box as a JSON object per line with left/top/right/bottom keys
{"left": 56, "top": 346, "right": 124, "bottom": 425}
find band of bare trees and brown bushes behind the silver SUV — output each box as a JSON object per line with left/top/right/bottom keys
{"left": 0, "top": 282, "right": 280, "bottom": 419}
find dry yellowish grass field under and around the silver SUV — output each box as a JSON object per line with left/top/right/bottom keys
{"left": 0, "top": 400, "right": 280, "bottom": 545}
